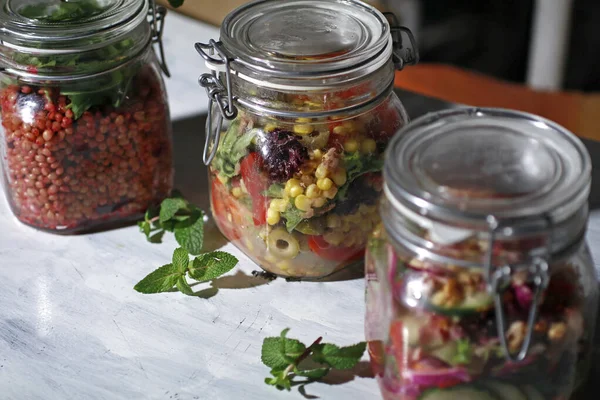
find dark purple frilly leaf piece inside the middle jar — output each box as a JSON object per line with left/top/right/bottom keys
{"left": 258, "top": 129, "right": 308, "bottom": 183}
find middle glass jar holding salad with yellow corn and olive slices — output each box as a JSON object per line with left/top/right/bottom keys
{"left": 197, "top": 0, "right": 417, "bottom": 279}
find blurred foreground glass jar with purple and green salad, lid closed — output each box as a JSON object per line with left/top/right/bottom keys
{"left": 365, "top": 108, "right": 598, "bottom": 400}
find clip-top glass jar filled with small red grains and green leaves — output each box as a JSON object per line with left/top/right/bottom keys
{"left": 0, "top": 0, "right": 173, "bottom": 233}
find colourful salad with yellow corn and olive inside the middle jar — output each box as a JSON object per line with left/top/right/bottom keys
{"left": 210, "top": 93, "right": 406, "bottom": 279}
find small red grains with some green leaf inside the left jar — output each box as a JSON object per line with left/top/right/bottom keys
{"left": 0, "top": 64, "right": 173, "bottom": 233}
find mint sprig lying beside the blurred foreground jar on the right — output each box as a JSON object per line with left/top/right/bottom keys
{"left": 261, "top": 328, "right": 367, "bottom": 390}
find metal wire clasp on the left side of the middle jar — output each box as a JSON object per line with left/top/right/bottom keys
{"left": 194, "top": 39, "right": 238, "bottom": 165}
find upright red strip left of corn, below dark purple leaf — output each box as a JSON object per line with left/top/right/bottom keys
{"left": 240, "top": 152, "right": 269, "bottom": 225}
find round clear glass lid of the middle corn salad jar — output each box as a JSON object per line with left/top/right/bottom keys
{"left": 221, "top": 0, "right": 391, "bottom": 75}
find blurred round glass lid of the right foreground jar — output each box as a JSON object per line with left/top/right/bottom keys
{"left": 384, "top": 108, "right": 591, "bottom": 236}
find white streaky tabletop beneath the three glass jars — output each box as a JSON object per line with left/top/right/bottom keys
{"left": 0, "top": 9, "right": 600, "bottom": 400}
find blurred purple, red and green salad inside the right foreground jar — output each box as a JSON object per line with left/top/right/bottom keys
{"left": 366, "top": 227, "right": 597, "bottom": 400}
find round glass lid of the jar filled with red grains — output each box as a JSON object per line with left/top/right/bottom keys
{"left": 0, "top": 0, "right": 148, "bottom": 51}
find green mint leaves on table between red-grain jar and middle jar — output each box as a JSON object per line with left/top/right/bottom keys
{"left": 134, "top": 192, "right": 238, "bottom": 296}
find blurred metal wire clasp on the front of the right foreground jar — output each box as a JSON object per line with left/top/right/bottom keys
{"left": 484, "top": 216, "right": 553, "bottom": 362}
